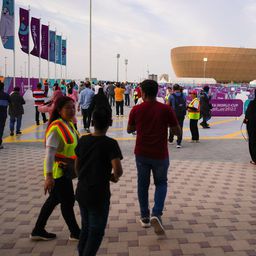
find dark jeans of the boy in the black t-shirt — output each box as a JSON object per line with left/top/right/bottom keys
{"left": 78, "top": 199, "right": 109, "bottom": 256}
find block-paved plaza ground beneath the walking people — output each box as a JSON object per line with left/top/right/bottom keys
{"left": 0, "top": 101, "right": 256, "bottom": 256}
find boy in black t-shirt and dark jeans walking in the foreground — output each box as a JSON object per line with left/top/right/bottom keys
{"left": 75, "top": 108, "right": 123, "bottom": 256}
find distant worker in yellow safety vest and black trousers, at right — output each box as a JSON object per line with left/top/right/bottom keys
{"left": 187, "top": 90, "right": 200, "bottom": 142}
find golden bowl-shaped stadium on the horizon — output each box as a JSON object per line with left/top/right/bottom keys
{"left": 171, "top": 46, "right": 256, "bottom": 83}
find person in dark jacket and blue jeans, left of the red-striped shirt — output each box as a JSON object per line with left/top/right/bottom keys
{"left": 8, "top": 87, "right": 26, "bottom": 136}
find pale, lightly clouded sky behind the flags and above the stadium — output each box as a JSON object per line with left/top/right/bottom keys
{"left": 0, "top": 0, "right": 256, "bottom": 81}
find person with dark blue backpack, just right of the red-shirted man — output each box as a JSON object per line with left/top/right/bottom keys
{"left": 167, "top": 84, "right": 186, "bottom": 148}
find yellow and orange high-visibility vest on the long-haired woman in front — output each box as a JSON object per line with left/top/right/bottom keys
{"left": 44, "top": 118, "right": 78, "bottom": 179}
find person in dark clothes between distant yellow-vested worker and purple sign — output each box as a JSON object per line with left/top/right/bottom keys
{"left": 200, "top": 85, "right": 212, "bottom": 129}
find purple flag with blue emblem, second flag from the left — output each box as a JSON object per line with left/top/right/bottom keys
{"left": 18, "top": 8, "right": 29, "bottom": 53}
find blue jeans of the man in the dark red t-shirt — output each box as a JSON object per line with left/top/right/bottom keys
{"left": 136, "top": 156, "right": 169, "bottom": 218}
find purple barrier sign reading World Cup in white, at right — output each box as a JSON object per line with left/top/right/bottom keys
{"left": 211, "top": 100, "right": 243, "bottom": 117}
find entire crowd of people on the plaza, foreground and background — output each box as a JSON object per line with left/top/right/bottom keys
{"left": 0, "top": 80, "right": 256, "bottom": 256}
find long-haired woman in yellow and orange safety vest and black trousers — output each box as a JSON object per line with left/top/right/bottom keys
{"left": 30, "top": 96, "right": 80, "bottom": 240}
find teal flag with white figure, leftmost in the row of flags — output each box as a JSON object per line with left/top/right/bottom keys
{"left": 0, "top": 0, "right": 14, "bottom": 50}
